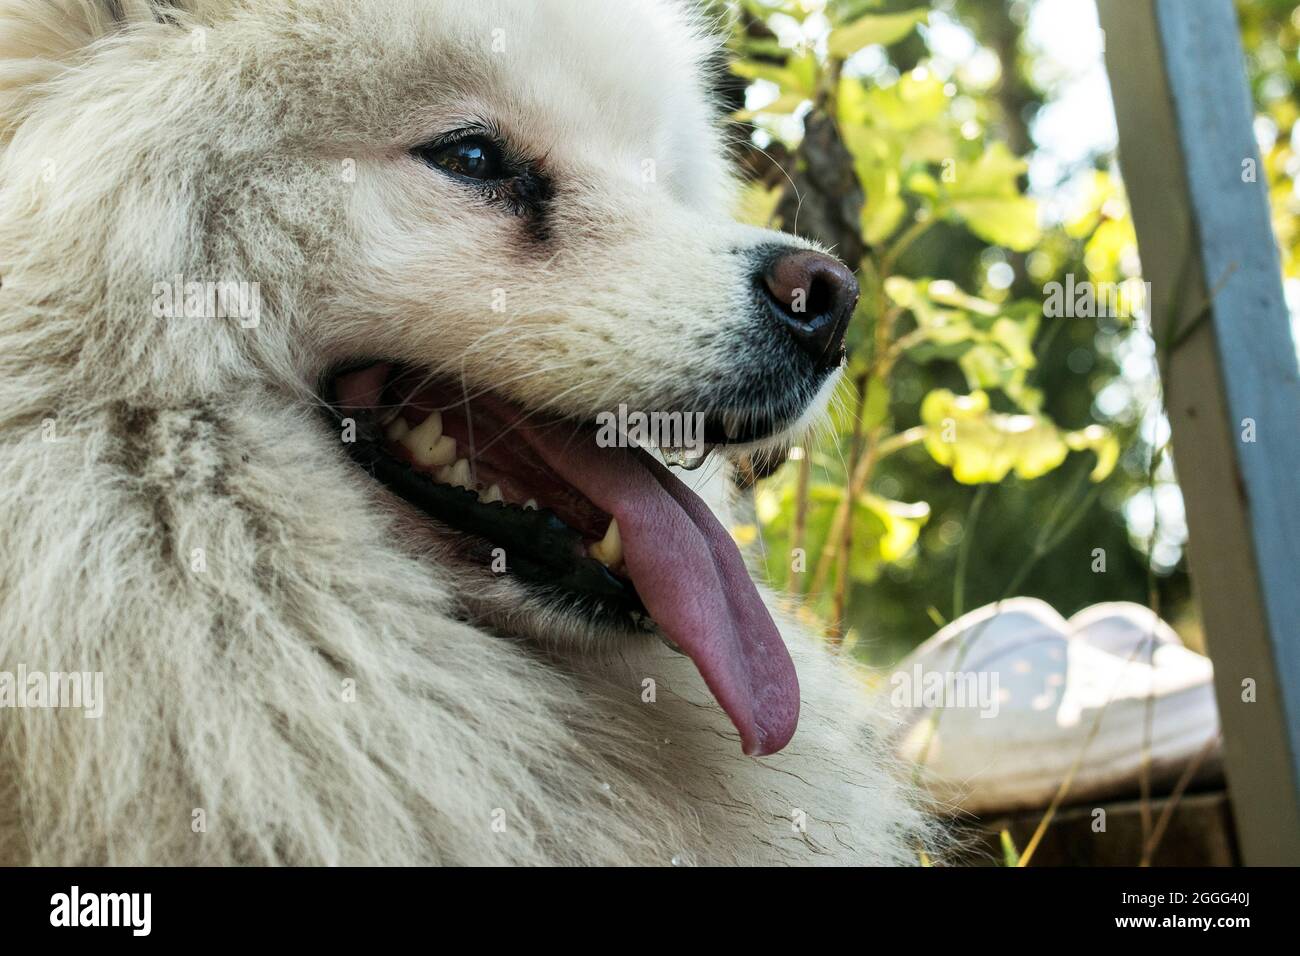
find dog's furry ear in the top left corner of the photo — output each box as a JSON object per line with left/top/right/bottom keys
{"left": 0, "top": 0, "right": 195, "bottom": 146}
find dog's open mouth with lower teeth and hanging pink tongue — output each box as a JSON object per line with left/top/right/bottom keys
{"left": 329, "top": 363, "right": 798, "bottom": 754}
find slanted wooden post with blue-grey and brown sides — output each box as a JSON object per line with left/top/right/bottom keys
{"left": 1099, "top": 0, "right": 1300, "bottom": 866}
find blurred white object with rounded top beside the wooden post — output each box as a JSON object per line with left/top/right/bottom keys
{"left": 888, "top": 597, "right": 1222, "bottom": 814}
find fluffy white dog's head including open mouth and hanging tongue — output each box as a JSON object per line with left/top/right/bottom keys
{"left": 0, "top": 0, "right": 857, "bottom": 752}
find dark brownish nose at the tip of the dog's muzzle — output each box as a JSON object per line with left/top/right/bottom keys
{"left": 763, "top": 248, "right": 858, "bottom": 368}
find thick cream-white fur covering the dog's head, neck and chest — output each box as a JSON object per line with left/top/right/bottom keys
{"left": 0, "top": 0, "right": 926, "bottom": 864}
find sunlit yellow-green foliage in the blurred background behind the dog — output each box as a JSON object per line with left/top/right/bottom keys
{"left": 718, "top": 0, "right": 1300, "bottom": 663}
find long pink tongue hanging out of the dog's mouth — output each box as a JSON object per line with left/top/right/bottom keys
{"left": 520, "top": 427, "right": 800, "bottom": 756}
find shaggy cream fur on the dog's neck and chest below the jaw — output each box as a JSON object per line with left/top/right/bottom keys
{"left": 0, "top": 377, "right": 935, "bottom": 864}
